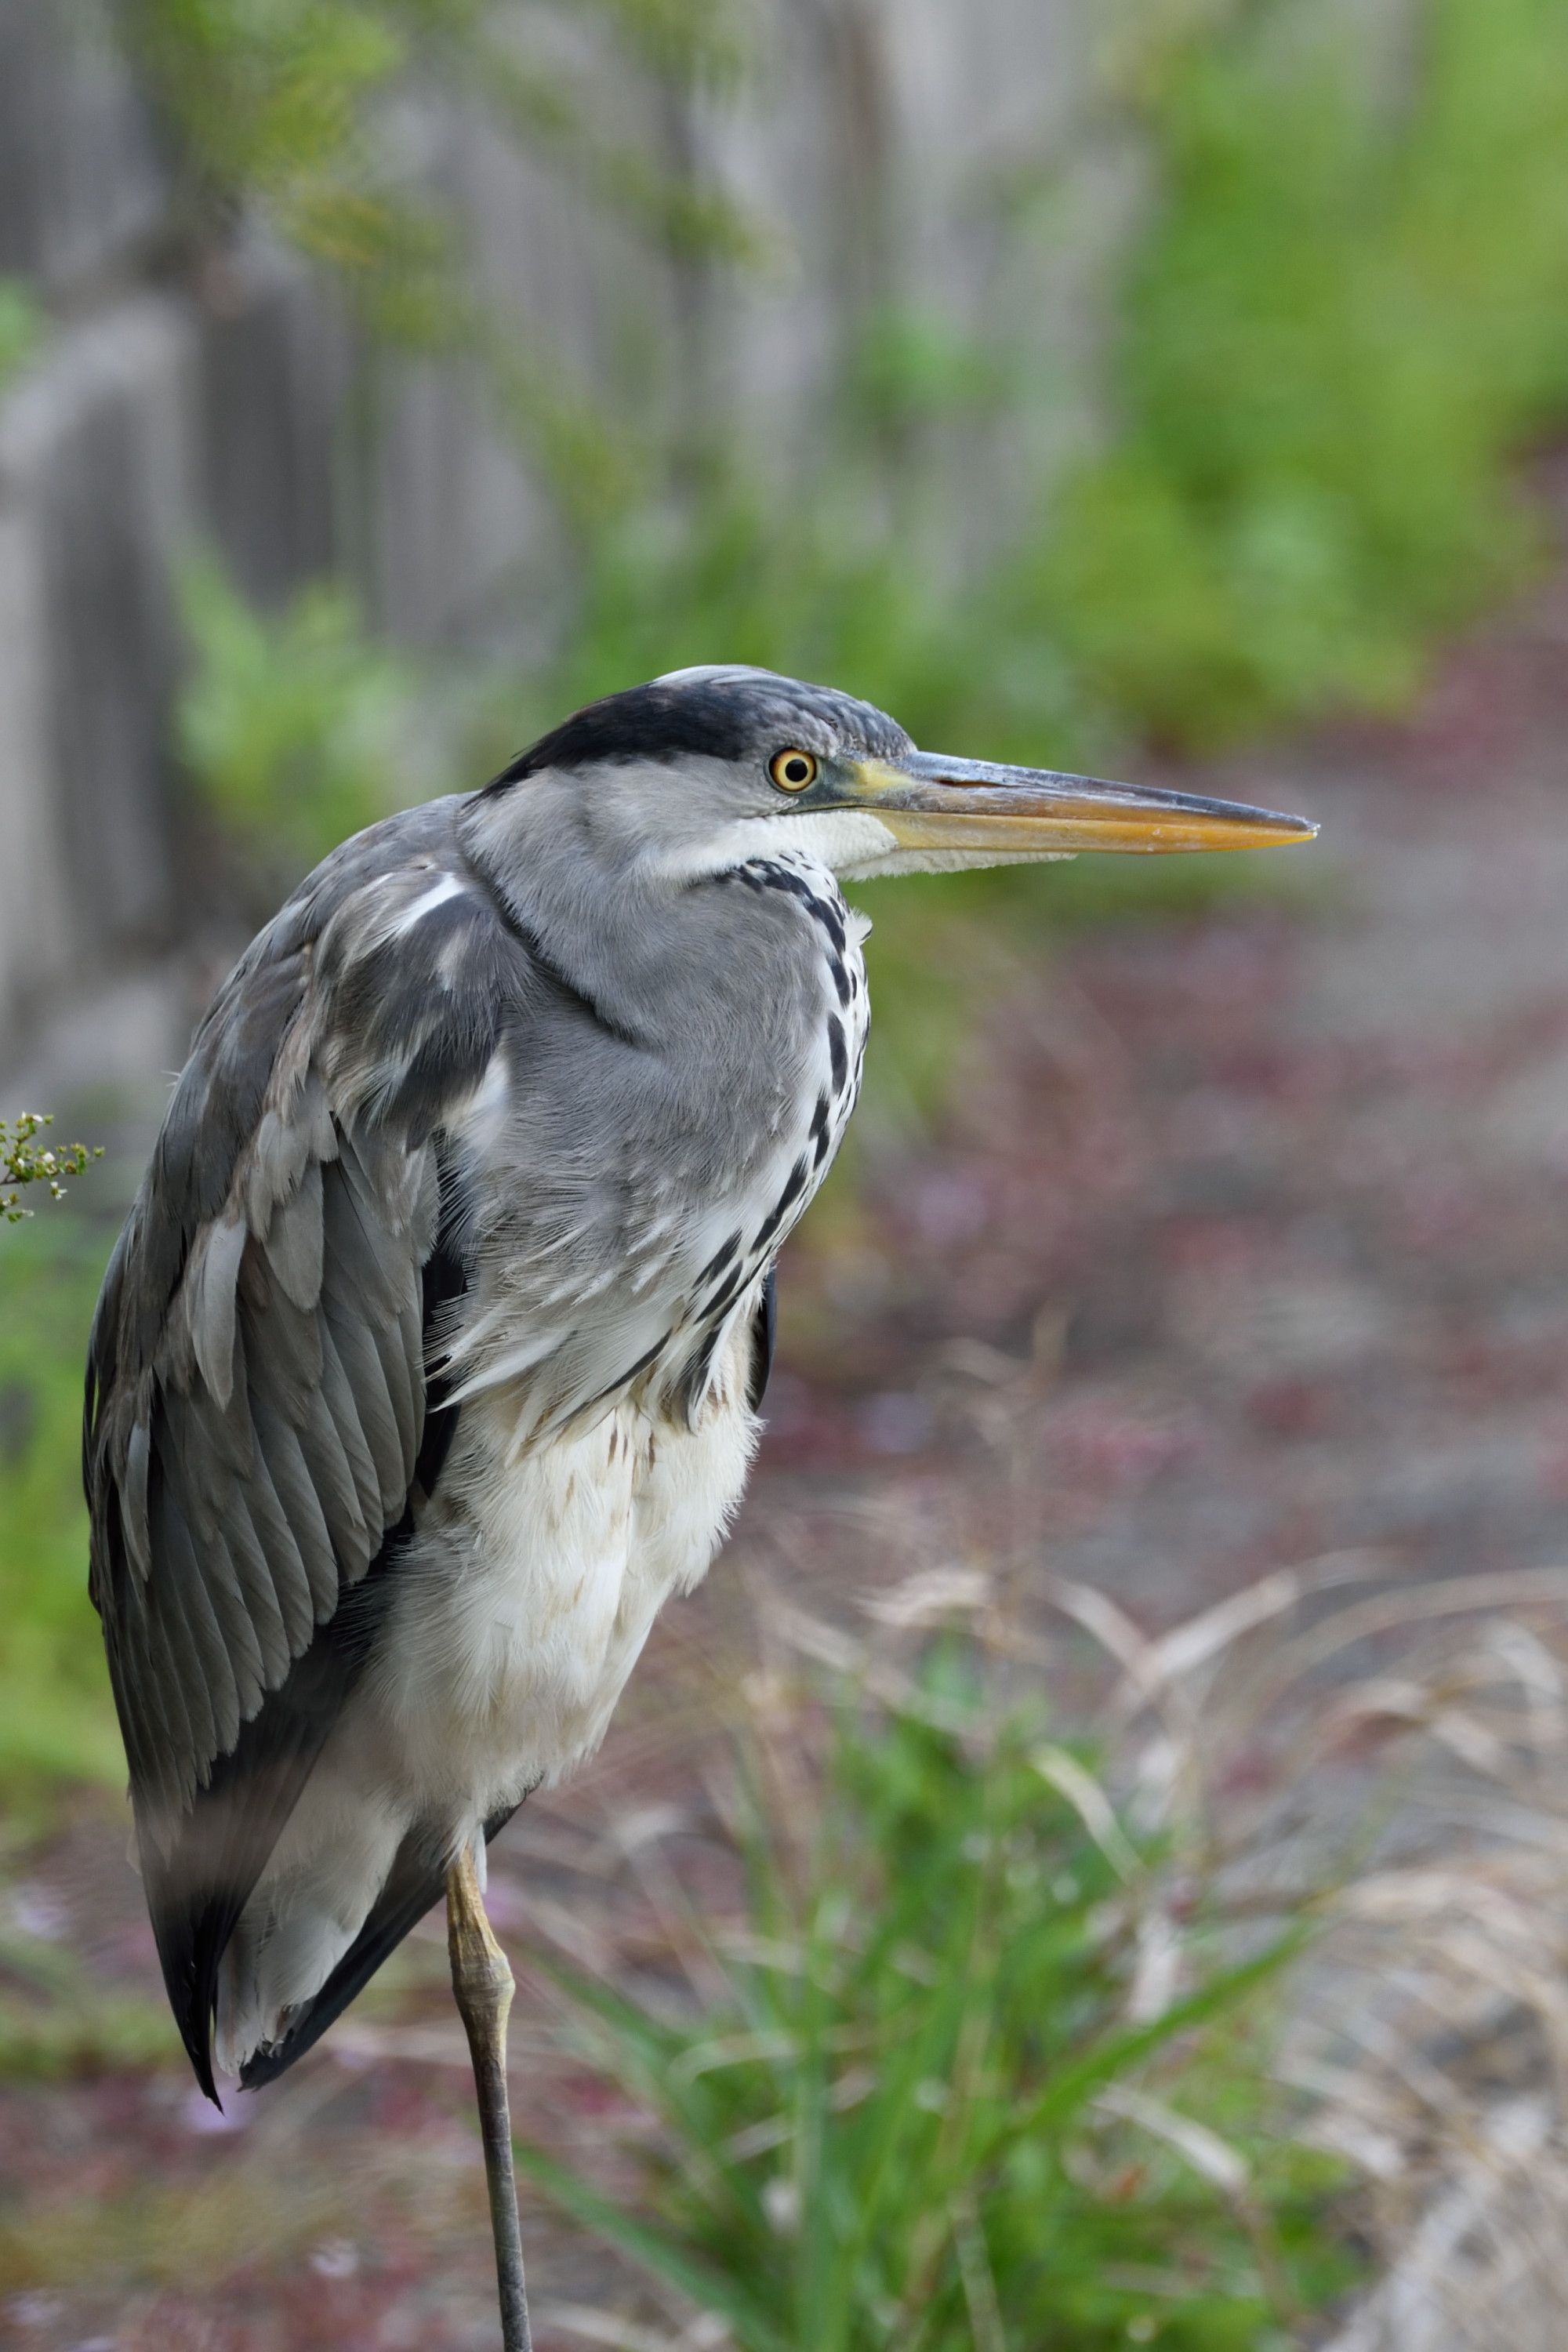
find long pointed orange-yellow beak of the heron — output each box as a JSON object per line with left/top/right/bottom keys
{"left": 832, "top": 750, "right": 1316, "bottom": 863}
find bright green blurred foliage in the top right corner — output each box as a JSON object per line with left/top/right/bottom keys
{"left": 1034, "top": 0, "right": 1568, "bottom": 748}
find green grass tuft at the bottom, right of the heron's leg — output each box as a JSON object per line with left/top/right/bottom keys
{"left": 522, "top": 1649, "right": 1354, "bottom": 2352}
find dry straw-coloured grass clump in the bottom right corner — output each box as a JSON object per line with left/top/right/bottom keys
{"left": 1011, "top": 1557, "right": 1568, "bottom": 2352}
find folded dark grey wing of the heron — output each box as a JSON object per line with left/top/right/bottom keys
{"left": 85, "top": 804, "right": 517, "bottom": 2091}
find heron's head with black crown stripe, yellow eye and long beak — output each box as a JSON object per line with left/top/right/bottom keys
{"left": 482, "top": 668, "right": 1316, "bottom": 880}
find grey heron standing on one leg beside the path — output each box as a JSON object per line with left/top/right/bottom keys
{"left": 85, "top": 668, "right": 1316, "bottom": 2352}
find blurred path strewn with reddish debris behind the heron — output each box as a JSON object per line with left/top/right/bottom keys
{"left": 0, "top": 487, "right": 1568, "bottom": 2352}
